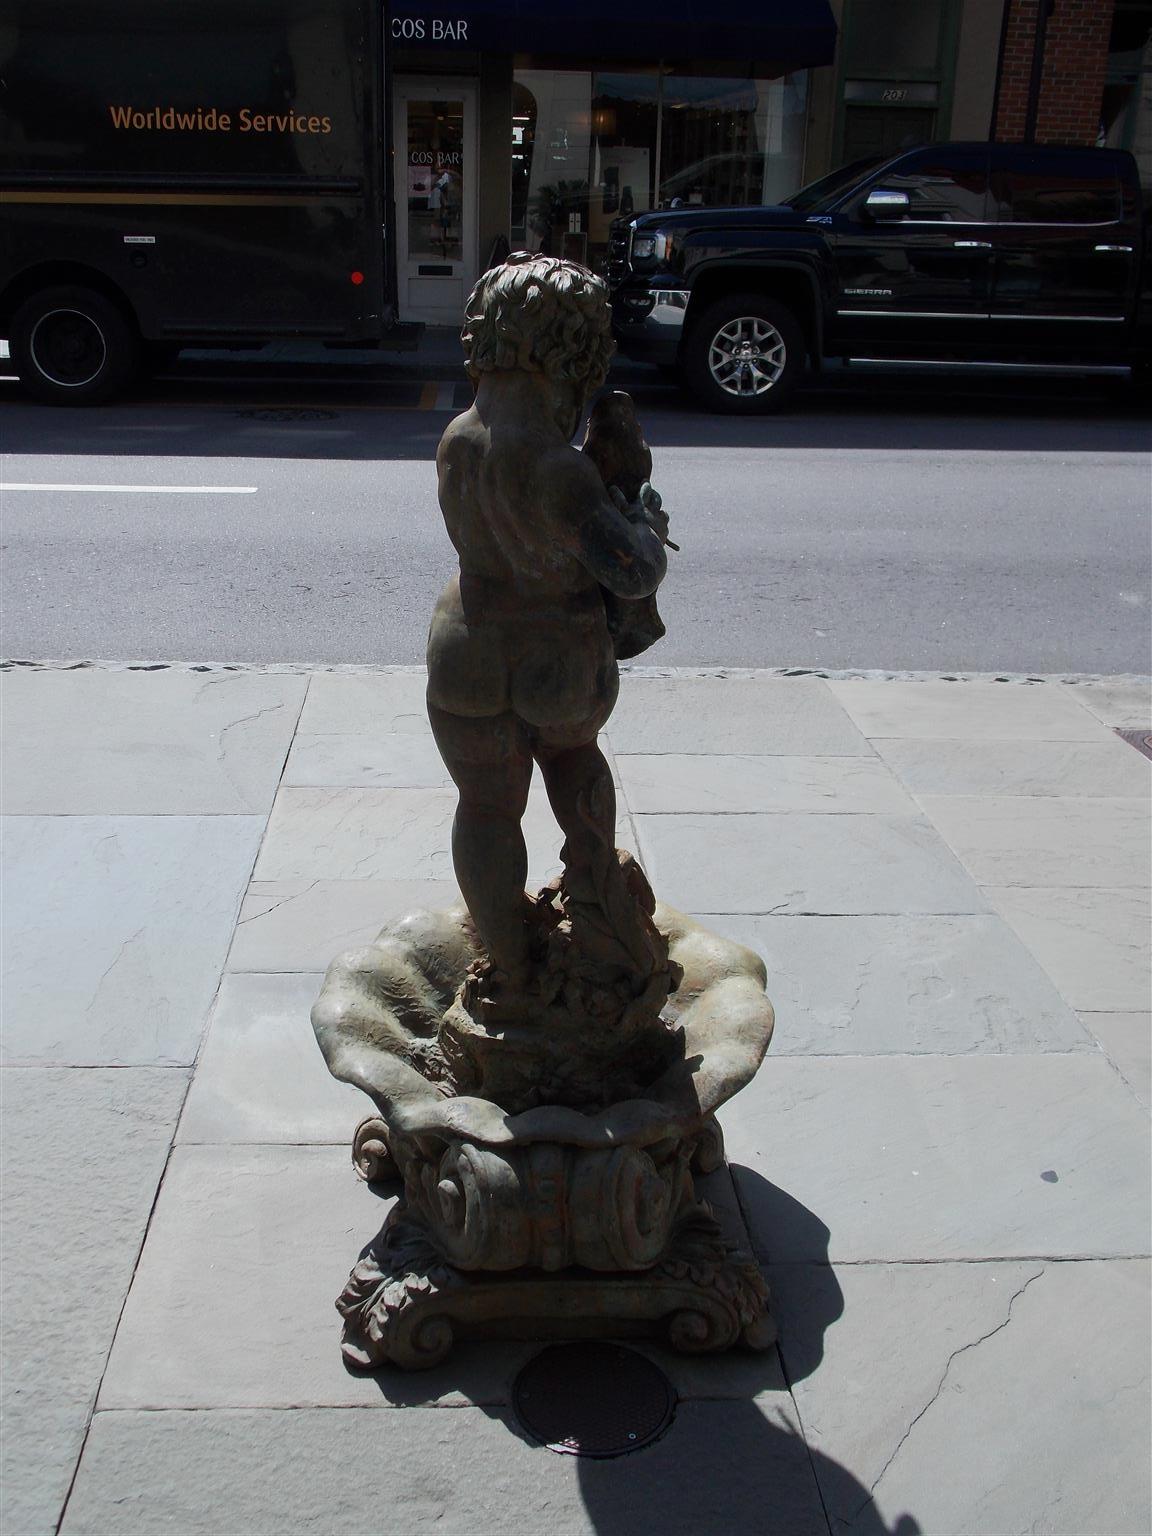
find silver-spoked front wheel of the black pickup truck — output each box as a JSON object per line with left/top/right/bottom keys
{"left": 684, "top": 293, "right": 805, "bottom": 415}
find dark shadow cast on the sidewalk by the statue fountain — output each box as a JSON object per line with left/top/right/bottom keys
{"left": 351, "top": 1166, "right": 922, "bottom": 1536}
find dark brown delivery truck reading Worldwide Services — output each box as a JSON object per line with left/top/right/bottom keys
{"left": 0, "top": 0, "right": 415, "bottom": 404}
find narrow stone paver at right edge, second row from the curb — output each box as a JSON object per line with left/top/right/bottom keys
{"left": 874, "top": 737, "right": 1152, "bottom": 799}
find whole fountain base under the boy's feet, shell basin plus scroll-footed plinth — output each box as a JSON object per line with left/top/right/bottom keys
{"left": 312, "top": 890, "right": 773, "bottom": 1366}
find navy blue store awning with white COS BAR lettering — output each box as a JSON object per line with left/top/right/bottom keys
{"left": 389, "top": 0, "right": 836, "bottom": 69}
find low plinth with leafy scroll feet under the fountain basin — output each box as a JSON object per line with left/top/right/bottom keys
{"left": 336, "top": 1161, "right": 776, "bottom": 1370}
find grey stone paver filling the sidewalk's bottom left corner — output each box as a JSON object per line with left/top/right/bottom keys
{"left": 0, "top": 1068, "right": 187, "bottom": 1536}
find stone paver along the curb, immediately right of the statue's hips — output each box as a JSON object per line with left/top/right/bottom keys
{"left": 608, "top": 673, "right": 872, "bottom": 757}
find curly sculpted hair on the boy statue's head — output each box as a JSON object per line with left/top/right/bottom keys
{"left": 461, "top": 250, "right": 616, "bottom": 393}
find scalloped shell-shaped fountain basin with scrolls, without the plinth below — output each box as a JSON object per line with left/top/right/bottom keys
{"left": 312, "top": 905, "right": 773, "bottom": 1272}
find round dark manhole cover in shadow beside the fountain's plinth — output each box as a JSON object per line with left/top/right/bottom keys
{"left": 511, "top": 1344, "right": 676, "bottom": 1456}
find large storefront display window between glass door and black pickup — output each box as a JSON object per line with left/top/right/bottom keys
{"left": 511, "top": 69, "right": 806, "bottom": 267}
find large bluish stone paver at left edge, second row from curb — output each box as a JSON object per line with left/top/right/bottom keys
{"left": 3, "top": 816, "right": 264, "bottom": 1066}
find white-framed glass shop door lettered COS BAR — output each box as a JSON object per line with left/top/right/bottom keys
{"left": 393, "top": 80, "right": 478, "bottom": 326}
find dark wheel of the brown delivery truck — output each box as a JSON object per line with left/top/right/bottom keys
{"left": 9, "top": 287, "right": 140, "bottom": 406}
